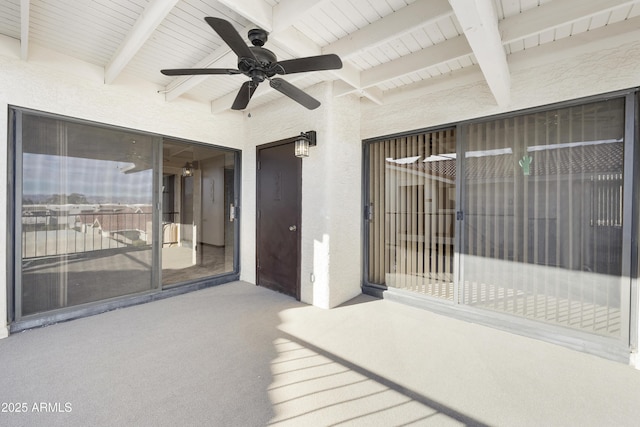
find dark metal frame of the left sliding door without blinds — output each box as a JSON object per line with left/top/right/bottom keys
{"left": 6, "top": 105, "right": 241, "bottom": 333}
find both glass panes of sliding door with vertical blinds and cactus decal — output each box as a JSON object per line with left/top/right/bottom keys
{"left": 365, "top": 95, "right": 637, "bottom": 339}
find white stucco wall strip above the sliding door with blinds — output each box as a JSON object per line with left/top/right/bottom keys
{"left": 361, "top": 40, "right": 640, "bottom": 139}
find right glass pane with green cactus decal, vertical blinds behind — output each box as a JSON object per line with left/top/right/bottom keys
{"left": 462, "top": 99, "right": 624, "bottom": 336}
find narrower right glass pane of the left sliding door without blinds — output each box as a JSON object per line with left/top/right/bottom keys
{"left": 162, "top": 139, "right": 236, "bottom": 287}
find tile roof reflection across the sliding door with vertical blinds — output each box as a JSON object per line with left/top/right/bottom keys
{"left": 396, "top": 142, "right": 624, "bottom": 180}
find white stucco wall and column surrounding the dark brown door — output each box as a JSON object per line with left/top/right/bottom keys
{"left": 241, "top": 84, "right": 362, "bottom": 308}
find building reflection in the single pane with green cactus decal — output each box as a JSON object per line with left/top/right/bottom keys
{"left": 465, "top": 139, "right": 624, "bottom": 275}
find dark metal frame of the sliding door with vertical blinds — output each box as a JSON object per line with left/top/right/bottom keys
{"left": 362, "top": 88, "right": 640, "bottom": 362}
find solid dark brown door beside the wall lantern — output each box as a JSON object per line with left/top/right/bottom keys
{"left": 256, "top": 142, "right": 302, "bottom": 299}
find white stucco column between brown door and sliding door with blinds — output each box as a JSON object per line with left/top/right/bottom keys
{"left": 301, "top": 85, "right": 362, "bottom": 308}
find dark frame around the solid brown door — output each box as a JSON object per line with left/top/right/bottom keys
{"left": 255, "top": 137, "right": 302, "bottom": 301}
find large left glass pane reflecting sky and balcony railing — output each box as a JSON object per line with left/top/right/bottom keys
{"left": 16, "top": 113, "right": 154, "bottom": 316}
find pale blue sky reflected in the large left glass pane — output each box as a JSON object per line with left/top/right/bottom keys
{"left": 22, "top": 153, "right": 153, "bottom": 203}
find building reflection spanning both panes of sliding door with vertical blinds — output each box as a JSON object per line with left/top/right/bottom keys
{"left": 385, "top": 135, "right": 624, "bottom": 275}
